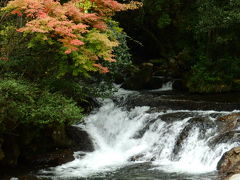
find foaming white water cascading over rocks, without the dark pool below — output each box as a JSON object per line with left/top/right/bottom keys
{"left": 41, "top": 87, "right": 239, "bottom": 179}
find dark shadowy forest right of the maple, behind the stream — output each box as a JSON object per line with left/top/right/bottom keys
{"left": 118, "top": 0, "right": 240, "bottom": 93}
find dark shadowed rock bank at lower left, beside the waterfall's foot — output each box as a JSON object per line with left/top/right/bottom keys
{"left": 0, "top": 126, "right": 94, "bottom": 180}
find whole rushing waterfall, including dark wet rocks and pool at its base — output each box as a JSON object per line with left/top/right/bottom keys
{"left": 39, "top": 84, "right": 240, "bottom": 180}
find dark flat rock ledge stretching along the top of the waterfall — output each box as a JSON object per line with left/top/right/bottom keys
{"left": 125, "top": 91, "right": 240, "bottom": 111}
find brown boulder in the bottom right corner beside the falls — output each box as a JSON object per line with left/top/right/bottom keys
{"left": 217, "top": 147, "right": 240, "bottom": 177}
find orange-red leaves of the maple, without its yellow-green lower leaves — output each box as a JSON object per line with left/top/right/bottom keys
{"left": 4, "top": 0, "right": 139, "bottom": 73}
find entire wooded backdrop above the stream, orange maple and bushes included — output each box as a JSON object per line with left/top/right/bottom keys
{"left": 0, "top": 0, "right": 240, "bottom": 172}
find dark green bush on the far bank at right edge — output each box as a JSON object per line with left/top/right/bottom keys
{"left": 188, "top": 57, "right": 240, "bottom": 93}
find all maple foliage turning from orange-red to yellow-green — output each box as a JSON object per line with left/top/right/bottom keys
{"left": 1, "top": 0, "right": 127, "bottom": 77}
